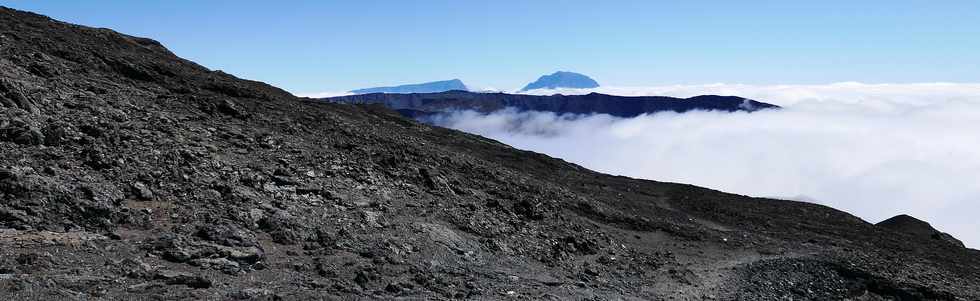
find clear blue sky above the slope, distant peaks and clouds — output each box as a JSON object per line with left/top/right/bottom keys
{"left": 0, "top": 0, "right": 980, "bottom": 92}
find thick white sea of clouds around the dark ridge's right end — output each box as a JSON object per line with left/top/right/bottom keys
{"left": 434, "top": 83, "right": 980, "bottom": 248}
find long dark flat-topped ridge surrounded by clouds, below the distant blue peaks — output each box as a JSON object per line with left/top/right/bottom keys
{"left": 323, "top": 91, "right": 778, "bottom": 117}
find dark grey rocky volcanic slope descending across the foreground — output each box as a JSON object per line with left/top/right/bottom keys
{"left": 0, "top": 8, "right": 980, "bottom": 300}
